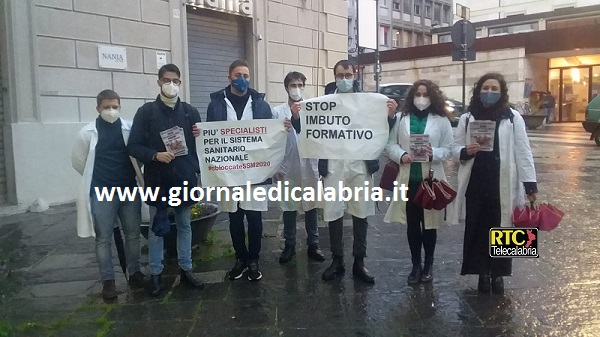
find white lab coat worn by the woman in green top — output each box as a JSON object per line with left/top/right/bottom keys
{"left": 384, "top": 114, "right": 453, "bottom": 229}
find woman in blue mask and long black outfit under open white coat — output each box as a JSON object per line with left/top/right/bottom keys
{"left": 448, "top": 73, "right": 537, "bottom": 294}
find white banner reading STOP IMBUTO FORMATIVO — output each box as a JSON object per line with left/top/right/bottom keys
{"left": 298, "top": 93, "right": 389, "bottom": 160}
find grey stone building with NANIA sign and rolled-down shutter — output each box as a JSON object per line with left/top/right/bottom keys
{"left": 0, "top": 0, "right": 348, "bottom": 207}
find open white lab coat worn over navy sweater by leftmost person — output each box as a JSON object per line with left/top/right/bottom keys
{"left": 71, "top": 119, "right": 150, "bottom": 238}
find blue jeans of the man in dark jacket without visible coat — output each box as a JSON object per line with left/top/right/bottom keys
{"left": 148, "top": 206, "right": 192, "bottom": 275}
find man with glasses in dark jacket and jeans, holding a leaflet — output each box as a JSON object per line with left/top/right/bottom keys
{"left": 127, "top": 64, "right": 204, "bottom": 297}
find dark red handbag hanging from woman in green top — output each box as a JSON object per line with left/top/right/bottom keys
{"left": 413, "top": 169, "right": 457, "bottom": 211}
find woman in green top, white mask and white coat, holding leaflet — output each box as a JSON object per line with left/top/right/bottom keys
{"left": 384, "top": 80, "right": 453, "bottom": 284}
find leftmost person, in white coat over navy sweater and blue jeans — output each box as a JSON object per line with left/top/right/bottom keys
{"left": 71, "top": 89, "right": 145, "bottom": 299}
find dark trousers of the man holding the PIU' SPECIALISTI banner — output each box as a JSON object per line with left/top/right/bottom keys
{"left": 229, "top": 207, "right": 262, "bottom": 261}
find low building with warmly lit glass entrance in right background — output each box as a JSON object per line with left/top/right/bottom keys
{"left": 361, "top": 5, "right": 600, "bottom": 122}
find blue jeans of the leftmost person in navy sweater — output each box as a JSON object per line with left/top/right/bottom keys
{"left": 90, "top": 195, "right": 142, "bottom": 281}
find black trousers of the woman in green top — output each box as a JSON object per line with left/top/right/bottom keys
{"left": 406, "top": 182, "right": 437, "bottom": 265}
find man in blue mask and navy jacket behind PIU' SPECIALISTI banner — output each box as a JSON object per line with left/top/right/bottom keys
{"left": 206, "top": 60, "right": 291, "bottom": 281}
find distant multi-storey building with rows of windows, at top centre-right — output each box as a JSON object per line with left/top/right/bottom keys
{"left": 348, "top": 0, "right": 454, "bottom": 56}
